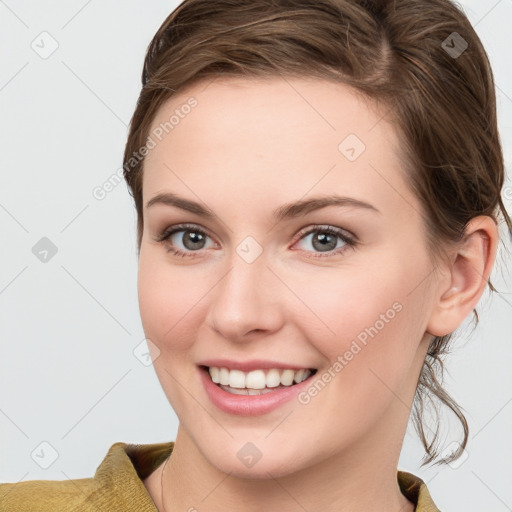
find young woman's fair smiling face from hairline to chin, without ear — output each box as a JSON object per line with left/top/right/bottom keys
{"left": 138, "top": 78, "right": 435, "bottom": 478}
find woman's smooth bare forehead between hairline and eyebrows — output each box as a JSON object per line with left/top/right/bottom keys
{"left": 143, "top": 78, "right": 414, "bottom": 217}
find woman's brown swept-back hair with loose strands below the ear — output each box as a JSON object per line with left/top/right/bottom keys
{"left": 123, "top": 0, "right": 512, "bottom": 464}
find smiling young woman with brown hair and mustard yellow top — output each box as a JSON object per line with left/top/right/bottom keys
{"left": 0, "top": 0, "right": 512, "bottom": 512}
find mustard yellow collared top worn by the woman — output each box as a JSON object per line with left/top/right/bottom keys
{"left": 0, "top": 442, "right": 440, "bottom": 512}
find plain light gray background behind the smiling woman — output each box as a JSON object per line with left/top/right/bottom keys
{"left": 0, "top": 0, "right": 512, "bottom": 512}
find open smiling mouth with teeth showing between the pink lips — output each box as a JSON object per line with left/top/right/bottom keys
{"left": 200, "top": 365, "right": 318, "bottom": 395}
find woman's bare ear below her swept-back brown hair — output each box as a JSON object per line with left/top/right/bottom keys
{"left": 427, "top": 215, "right": 498, "bottom": 336}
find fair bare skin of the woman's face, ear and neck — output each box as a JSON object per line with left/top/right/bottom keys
{"left": 138, "top": 78, "right": 497, "bottom": 512}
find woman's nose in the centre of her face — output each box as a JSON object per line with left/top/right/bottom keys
{"left": 207, "top": 254, "right": 285, "bottom": 342}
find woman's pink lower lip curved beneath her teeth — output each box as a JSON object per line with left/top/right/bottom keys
{"left": 199, "top": 367, "right": 316, "bottom": 416}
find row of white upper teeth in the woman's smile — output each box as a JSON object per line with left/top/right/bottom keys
{"left": 208, "top": 366, "right": 311, "bottom": 390}
